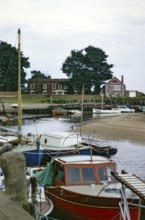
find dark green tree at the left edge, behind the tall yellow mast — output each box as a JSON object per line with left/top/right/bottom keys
{"left": 0, "top": 41, "right": 30, "bottom": 91}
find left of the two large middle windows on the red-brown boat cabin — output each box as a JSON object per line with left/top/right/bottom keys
{"left": 67, "top": 167, "right": 80, "bottom": 183}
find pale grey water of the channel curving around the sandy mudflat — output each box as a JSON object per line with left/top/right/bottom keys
{"left": 5, "top": 113, "right": 145, "bottom": 180}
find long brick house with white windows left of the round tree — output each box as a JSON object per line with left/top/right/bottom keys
{"left": 28, "top": 76, "right": 68, "bottom": 96}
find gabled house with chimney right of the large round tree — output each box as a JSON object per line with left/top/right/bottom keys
{"left": 102, "top": 76, "right": 126, "bottom": 97}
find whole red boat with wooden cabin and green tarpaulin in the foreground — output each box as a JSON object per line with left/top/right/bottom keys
{"left": 34, "top": 155, "right": 139, "bottom": 220}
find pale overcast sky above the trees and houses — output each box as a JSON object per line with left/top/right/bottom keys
{"left": 0, "top": 0, "right": 145, "bottom": 93}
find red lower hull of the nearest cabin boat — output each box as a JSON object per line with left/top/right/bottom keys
{"left": 46, "top": 188, "right": 138, "bottom": 220}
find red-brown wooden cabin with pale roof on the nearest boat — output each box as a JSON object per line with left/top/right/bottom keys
{"left": 52, "top": 155, "right": 116, "bottom": 186}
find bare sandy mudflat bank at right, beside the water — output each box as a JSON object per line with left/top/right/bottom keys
{"left": 81, "top": 112, "right": 145, "bottom": 145}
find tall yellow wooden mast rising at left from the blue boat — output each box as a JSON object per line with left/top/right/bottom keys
{"left": 18, "top": 29, "right": 22, "bottom": 143}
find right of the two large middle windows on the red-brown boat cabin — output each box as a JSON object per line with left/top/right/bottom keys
{"left": 82, "top": 168, "right": 95, "bottom": 183}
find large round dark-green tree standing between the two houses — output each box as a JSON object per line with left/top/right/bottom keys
{"left": 62, "top": 46, "right": 113, "bottom": 94}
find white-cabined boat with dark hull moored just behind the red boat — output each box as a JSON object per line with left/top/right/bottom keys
{"left": 40, "top": 132, "right": 117, "bottom": 164}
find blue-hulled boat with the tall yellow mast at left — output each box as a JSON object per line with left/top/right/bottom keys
{"left": 10, "top": 29, "right": 44, "bottom": 166}
